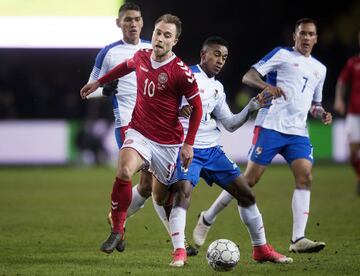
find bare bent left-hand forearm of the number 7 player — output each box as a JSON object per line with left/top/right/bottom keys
{"left": 242, "top": 68, "right": 286, "bottom": 100}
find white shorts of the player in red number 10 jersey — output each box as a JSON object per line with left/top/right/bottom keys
{"left": 121, "top": 129, "right": 180, "bottom": 186}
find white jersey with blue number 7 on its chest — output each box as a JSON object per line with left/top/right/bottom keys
{"left": 253, "top": 47, "right": 326, "bottom": 137}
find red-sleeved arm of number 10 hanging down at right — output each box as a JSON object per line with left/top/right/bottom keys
{"left": 180, "top": 93, "right": 202, "bottom": 169}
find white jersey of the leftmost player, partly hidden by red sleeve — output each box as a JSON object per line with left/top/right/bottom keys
{"left": 89, "top": 40, "right": 151, "bottom": 128}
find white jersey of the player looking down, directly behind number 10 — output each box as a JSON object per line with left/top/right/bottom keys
{"left": 180, "top": 65, "right": 233, "bottom": 148}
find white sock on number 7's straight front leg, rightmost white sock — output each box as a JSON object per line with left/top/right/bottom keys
{"left": 291, "top": 189, "right": 310, "bottom": 241}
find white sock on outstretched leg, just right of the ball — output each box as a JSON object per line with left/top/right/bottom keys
{"left": 238, "top": 203, "right": 266, "bottom": 246}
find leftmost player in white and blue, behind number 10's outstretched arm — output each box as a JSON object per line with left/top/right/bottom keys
{"left": 88, "top": 3, "right": 152, "bottom": 252}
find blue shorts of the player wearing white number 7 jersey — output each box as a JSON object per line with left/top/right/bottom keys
{"left": 249, "top": 127, "right": 314, "bottom": 166}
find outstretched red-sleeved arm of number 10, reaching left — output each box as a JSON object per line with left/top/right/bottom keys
{"left": 80, "top": 59, "right": 134, "bottom": 99}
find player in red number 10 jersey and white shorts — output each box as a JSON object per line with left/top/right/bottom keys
{"left": 80, "top": 14, "right": 202, "bottom": 266}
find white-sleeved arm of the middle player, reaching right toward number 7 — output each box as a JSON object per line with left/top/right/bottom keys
{"left": 218, "top": 90, "right": 273, "bottom": 132}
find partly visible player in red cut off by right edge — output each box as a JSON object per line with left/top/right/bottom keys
{"left": 334, "top": 31, "right": 360, "bottom": 196}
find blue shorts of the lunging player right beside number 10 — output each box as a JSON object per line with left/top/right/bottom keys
{"left": 176, "top": 146, "right": 241, "bottom": 188}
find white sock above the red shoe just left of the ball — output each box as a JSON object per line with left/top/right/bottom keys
{"left": 169, "top": 207, "right": 186, "bottom": 250}
